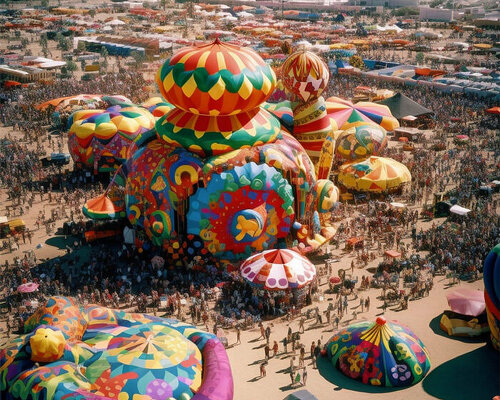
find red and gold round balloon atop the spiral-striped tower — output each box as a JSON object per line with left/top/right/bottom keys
{"left": 281, "top": 51, "right": 329, "bottom": 101}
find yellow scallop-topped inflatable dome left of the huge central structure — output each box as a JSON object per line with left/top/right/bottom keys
{"left": 68, "top": 105, "right": 155, "bottom": 173}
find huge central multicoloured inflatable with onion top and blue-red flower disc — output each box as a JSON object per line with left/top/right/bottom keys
{"left": 84, "top": 40, "right": 338, "bottom": 260}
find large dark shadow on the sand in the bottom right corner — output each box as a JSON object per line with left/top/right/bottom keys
{"left": 423, "top": 344, "right": 500, "bottom": 400}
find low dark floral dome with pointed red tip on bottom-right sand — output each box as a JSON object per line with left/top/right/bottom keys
{"left": 326, "top": 317, "right": 430, "bottom": 386}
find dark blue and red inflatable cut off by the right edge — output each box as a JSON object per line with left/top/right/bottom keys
{"left": 483, "top": 244, "right": 500, "bottom": 351}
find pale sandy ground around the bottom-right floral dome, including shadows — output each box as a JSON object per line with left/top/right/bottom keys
{"left": 228, "top": 270, "right": 500, "bottom": 400}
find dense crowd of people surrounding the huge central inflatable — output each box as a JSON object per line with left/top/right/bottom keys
{"left": 0, "top": 52, "right": 500, "bottom": 356}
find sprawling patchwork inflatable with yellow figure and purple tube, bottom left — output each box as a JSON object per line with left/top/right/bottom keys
{"left": 0, "top": 297, "right": 233, "bottom": 400}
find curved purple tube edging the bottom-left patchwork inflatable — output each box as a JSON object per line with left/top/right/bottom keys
{"left": 192, "top": 339, "right": 234, "bottom": 400}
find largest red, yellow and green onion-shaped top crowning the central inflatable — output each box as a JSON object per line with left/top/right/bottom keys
{"left": 156, "top": 39, "right": 276, "bottom": 116}
